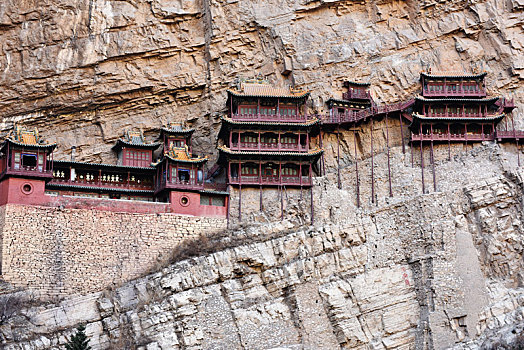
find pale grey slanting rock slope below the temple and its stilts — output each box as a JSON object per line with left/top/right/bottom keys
{"left": 0, "top": 145, "right": 524, "bottom": 350}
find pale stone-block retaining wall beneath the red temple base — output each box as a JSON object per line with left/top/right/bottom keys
{"left": 0, "top": 205, "right": 226, "bottom": 295}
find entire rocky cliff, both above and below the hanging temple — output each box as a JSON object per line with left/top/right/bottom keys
{"left": 0, "top": 0, "right": 524, "bottom": 350}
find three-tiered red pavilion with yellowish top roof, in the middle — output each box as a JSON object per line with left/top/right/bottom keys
{"left": 219, "top": 80, "right": 322, "bottom": 187}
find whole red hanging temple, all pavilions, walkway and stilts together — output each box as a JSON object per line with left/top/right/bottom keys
{"left": 0, "top": 71, "right": 524, "bottom": 220}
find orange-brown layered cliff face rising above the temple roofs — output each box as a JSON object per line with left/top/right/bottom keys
{"left": 0, "top": 0, "right": 524, "bottom": 161}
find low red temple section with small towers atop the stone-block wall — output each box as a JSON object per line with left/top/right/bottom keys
{"left": 0, "top": 124, "right": 228, "bottom": 216}
